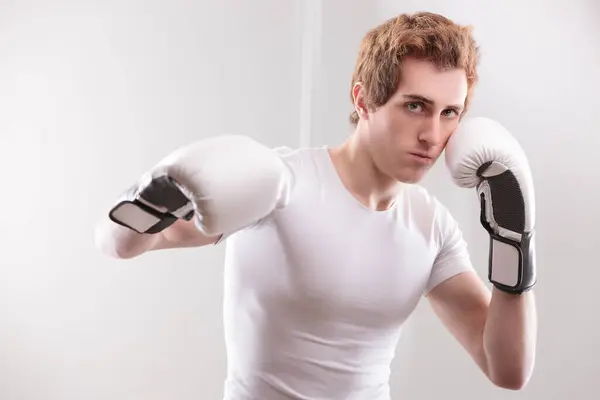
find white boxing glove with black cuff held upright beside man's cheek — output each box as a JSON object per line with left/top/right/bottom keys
{"left": 445, "top": 117, "right": 537, "bottom": 293}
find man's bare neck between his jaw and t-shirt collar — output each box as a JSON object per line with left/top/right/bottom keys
{"left": 330, "top": 132, "right": 406, "bottom": 211}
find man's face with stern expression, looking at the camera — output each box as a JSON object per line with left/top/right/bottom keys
{"left": 354, "top": 59, "right": 468, "bottom": 183}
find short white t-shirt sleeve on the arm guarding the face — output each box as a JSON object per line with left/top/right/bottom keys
{"left": 425, "top": 203, "right": 474, "bottom": 295}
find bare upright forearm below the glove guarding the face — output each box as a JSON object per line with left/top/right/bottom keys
{"left": 483, "top": 289, "right": 537, "bottom": 389}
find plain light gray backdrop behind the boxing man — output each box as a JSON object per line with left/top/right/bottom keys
{"left": 0, "top": 0, "right": 600, "bottom": 400}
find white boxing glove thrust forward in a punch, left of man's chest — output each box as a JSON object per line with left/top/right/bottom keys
{"left": 109, "top": 135, "right": 293, "bottom": 236}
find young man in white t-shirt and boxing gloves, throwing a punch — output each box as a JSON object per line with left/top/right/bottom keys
{"left": 96, "top": 13, "right": 536, "bottom": 400}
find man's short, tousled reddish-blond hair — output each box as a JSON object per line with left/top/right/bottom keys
{"left": 350, "top": 12, "right": 479, "bottom": 125}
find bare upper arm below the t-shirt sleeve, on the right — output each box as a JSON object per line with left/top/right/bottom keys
{"left": 427, "top": 271, "right": 491, "bottom": 369}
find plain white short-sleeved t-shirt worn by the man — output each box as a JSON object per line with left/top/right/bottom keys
{"left": 218, "top": 147, "right": 472, "bottom": 400}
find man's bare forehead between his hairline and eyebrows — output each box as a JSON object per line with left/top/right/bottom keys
{"left": 397, "top": 58, "right": 468, "bottom": 105}
